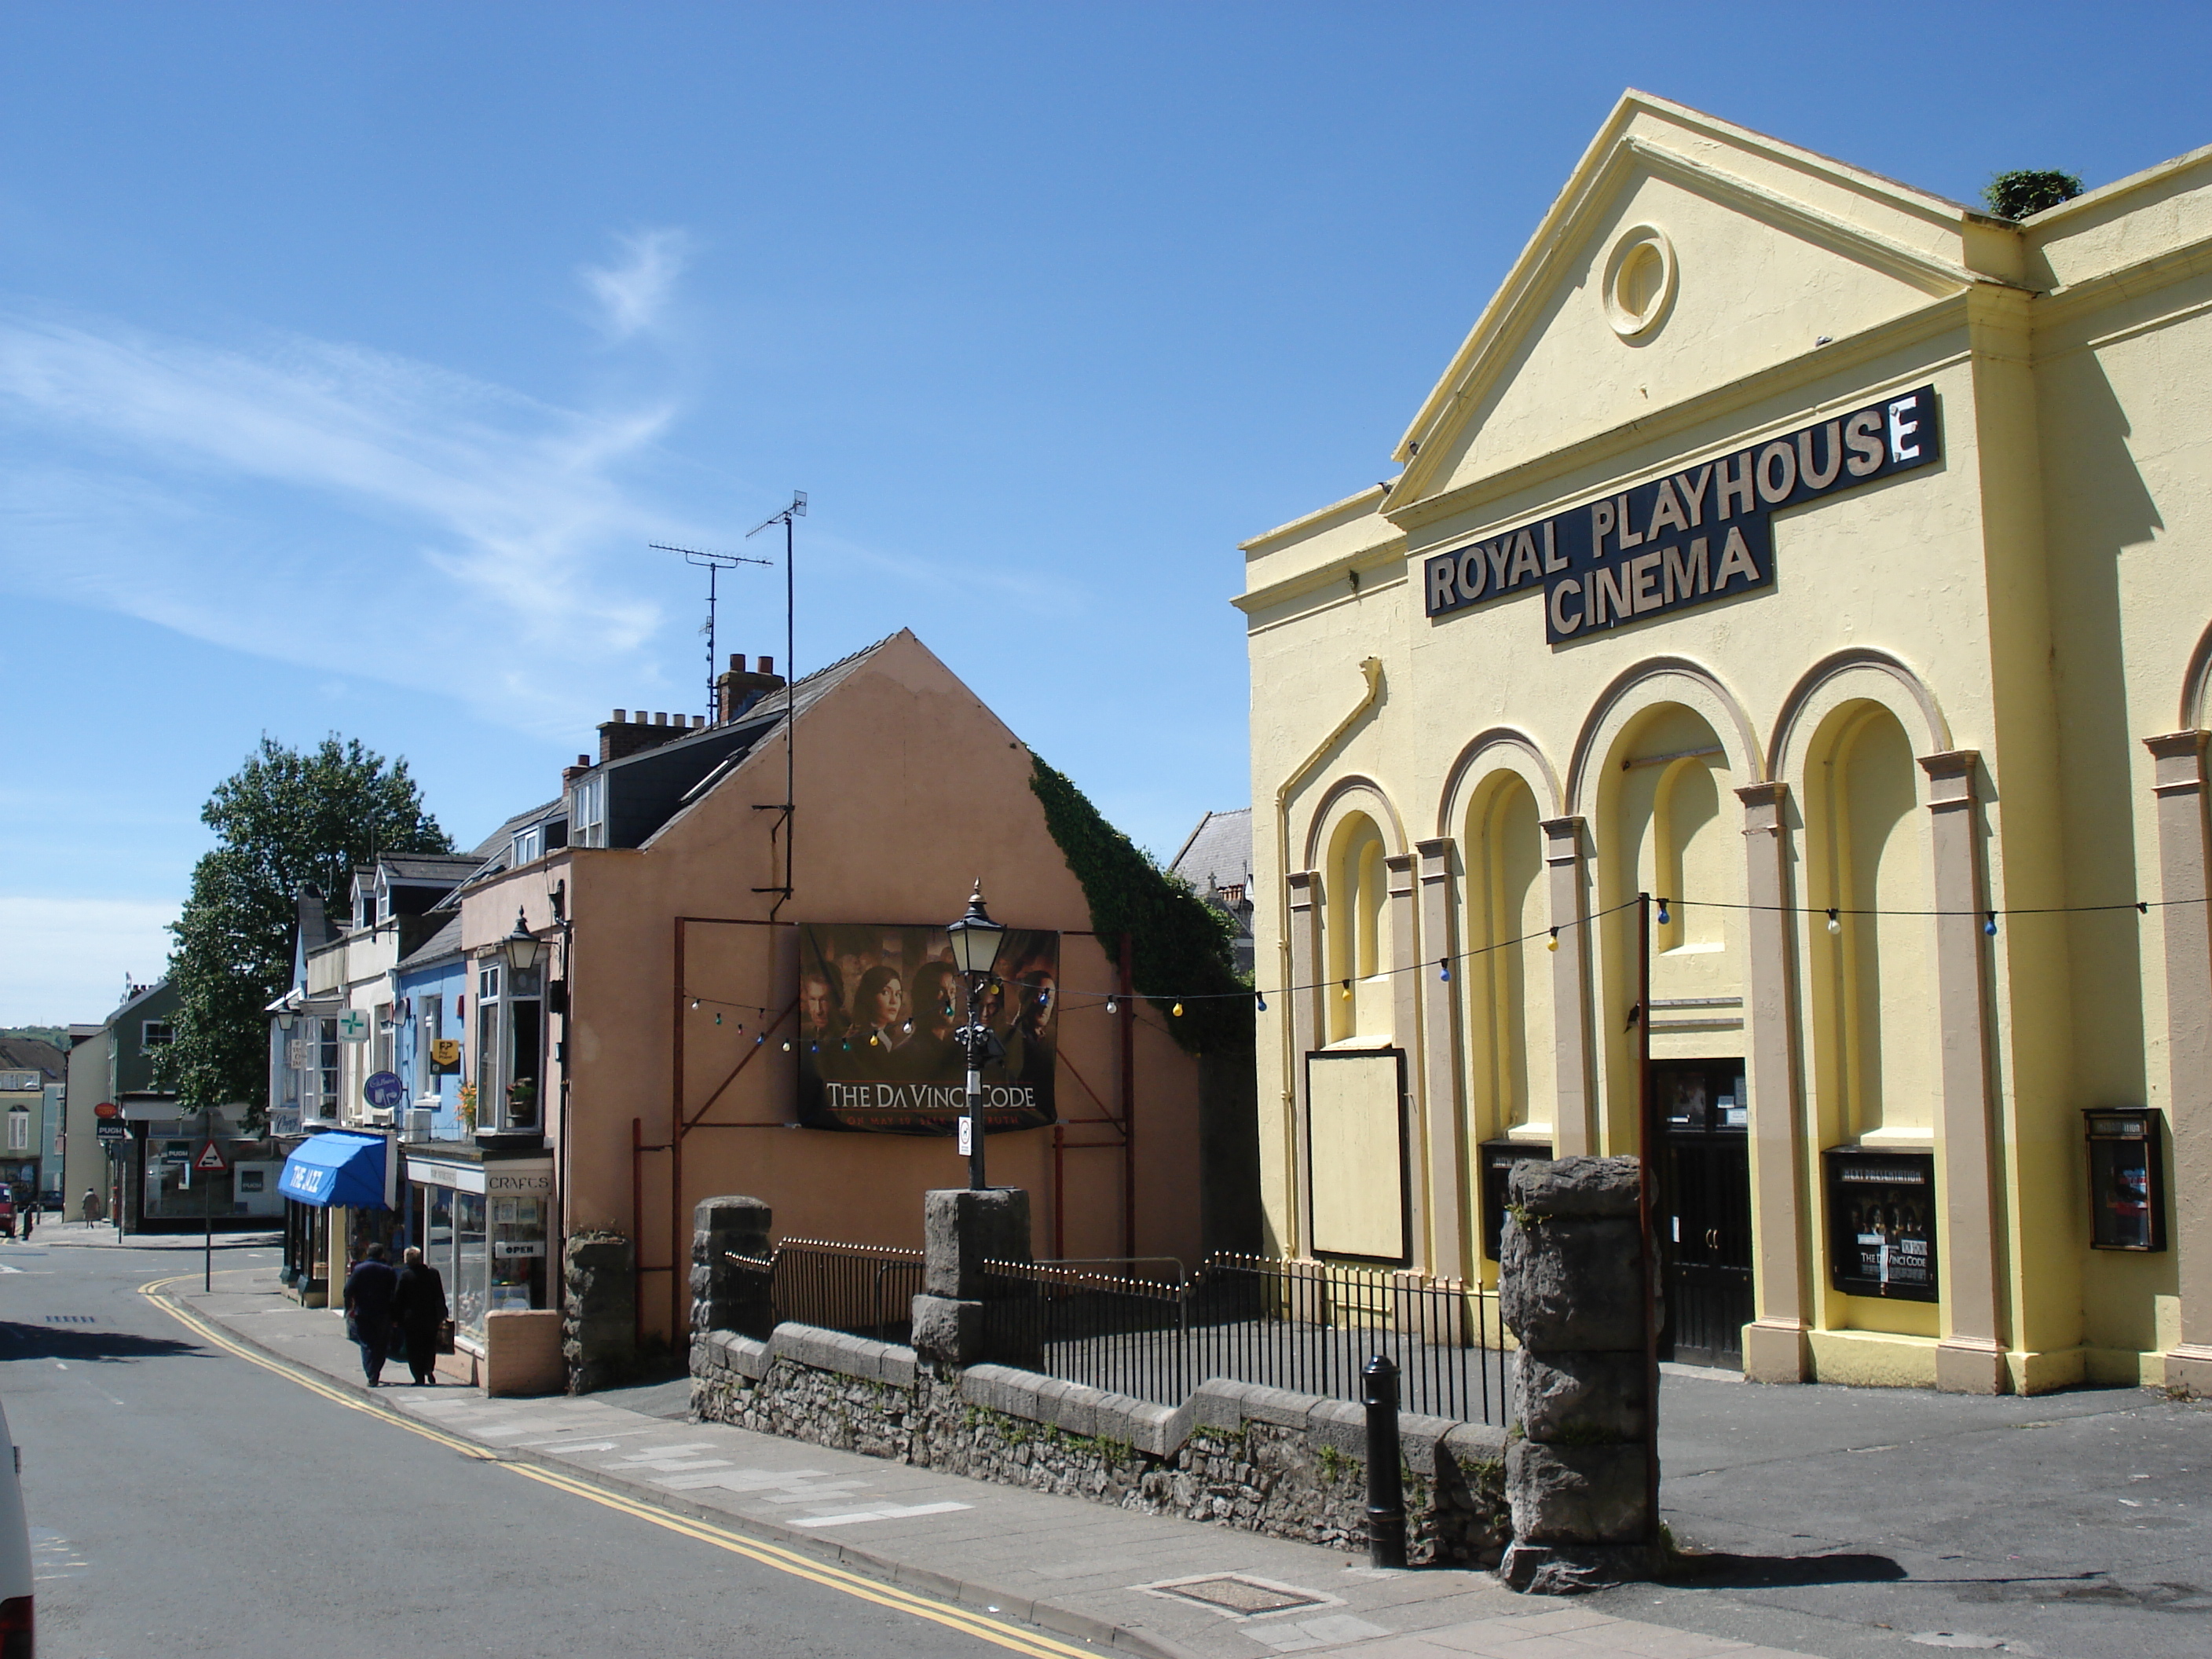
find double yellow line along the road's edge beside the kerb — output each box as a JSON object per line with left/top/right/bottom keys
{"left": 139, "top": 1279, "right": 1100, "bottom": 1659}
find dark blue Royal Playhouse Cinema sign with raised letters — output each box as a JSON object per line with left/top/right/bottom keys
{"left": 1423, "top": 385, "right": 1942, "bottom": 646}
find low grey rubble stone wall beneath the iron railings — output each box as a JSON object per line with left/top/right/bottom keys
{"left": 692, "top": 1325, "right": 1511, "bottom": 1566}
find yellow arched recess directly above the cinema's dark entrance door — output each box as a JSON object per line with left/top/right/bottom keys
{"left": 1581, "top": 690, "right": 1759, "bottom": 1152}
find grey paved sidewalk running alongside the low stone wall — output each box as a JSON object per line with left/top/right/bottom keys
{"left": 173, "top": 1269, "right": 1831, "bottom": 1659}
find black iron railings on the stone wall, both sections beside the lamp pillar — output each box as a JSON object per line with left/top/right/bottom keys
{"left": 730, "top": 1239, "right": 1511, "bottom": 1425}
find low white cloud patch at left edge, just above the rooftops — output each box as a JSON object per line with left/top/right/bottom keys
{"left": 0, "top": 894, "right": 177, "bottom": 1027}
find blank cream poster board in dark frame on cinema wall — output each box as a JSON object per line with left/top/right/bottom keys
{"left": 1305, "top": 1049, "right": 1413, "bottom": 1268}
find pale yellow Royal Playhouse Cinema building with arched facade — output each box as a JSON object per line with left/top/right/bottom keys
{"left": 1239, "top": 93, "right": 2212, "bottom": 1393}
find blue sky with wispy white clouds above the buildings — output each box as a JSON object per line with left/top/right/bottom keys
{"left": 0, "top": 0, "right": 2212, "bottom": 1024}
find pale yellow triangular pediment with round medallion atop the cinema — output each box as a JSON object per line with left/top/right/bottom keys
{"left": 1389, "top": 93, "right": 2017, "bottom": 513}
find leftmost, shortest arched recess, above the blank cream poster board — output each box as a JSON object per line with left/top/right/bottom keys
{"left": 1305, "top": 778, "right": 1404, "bottom": 1042}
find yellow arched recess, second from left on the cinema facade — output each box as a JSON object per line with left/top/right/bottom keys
{"left": 1458, "top": 769, "right": 1559, "bottom": 1159}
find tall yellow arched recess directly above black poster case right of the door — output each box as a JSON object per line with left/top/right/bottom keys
{"left": 1800, "top": 697, "right": 1942, "bottom": 1146}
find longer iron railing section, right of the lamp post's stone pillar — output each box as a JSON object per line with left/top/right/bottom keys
{"left": 989, "top": 1254, "right": 1511, "bottom": 1425}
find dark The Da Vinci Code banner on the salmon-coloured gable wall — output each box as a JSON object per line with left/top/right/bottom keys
{"left": 797, "top": 922, "right": 1060, "bottom": 1135}
